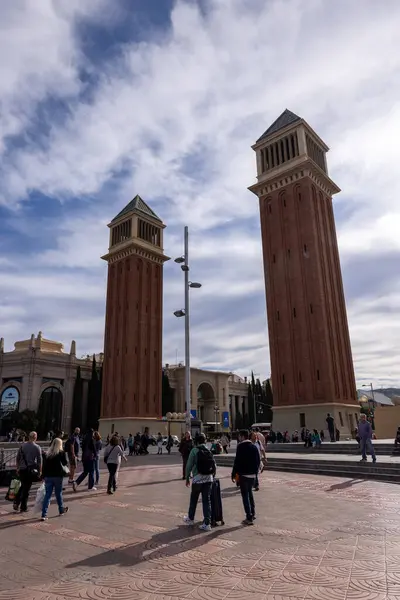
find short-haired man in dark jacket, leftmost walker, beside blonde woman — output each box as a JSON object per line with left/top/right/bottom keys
{"left": 13, "top": 431, "right": 42, "bottom": 513}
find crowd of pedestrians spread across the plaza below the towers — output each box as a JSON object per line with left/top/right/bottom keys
{"left": 7, "top": 414, "right": 382, "bottom": 531}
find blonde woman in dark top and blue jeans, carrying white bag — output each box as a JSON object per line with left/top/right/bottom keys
{"left": 42, "top": 438, "right": 69, "bottom": 521}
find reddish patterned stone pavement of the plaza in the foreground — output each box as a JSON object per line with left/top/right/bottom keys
{"left": 0, "top": 456, "right": 400, "bottom": 600}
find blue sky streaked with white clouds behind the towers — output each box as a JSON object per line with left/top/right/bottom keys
{"left": 0, "top": 0, "right": 400, "bottom": 386}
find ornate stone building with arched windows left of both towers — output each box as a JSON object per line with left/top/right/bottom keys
{"left": 0, "top": 332, "right": 103, "bottom": 435}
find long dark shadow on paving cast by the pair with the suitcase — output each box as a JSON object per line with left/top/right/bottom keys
{"left": 67, "top": 525, "right": 243, "bottom": 569}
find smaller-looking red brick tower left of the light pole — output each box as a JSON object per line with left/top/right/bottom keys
{"left": 100, "top": 196, "right": 168, "bottom": 435}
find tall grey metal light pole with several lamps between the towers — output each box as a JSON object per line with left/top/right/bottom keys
{"left": 174, "top": 225, "right": 201, "bottom": 432}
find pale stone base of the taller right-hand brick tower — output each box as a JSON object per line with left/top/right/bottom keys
{"left": 272, "top": 403, "right": 360, "bottom": 440}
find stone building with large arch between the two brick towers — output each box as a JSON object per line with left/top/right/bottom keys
{"left": 164, "top": 364, "right": 248, "bottom": 431}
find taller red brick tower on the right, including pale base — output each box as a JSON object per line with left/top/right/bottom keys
{"left": 249, "top": 110, "right": 359, "bottom": 436}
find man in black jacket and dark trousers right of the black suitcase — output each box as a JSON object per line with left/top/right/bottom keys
{"left": 232, "top": 430, "right": 260, "bottom": 525}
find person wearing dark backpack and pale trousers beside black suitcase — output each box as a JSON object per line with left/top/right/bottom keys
{"left": 184, "top": 434, "right": 216, "bottom": 531}
